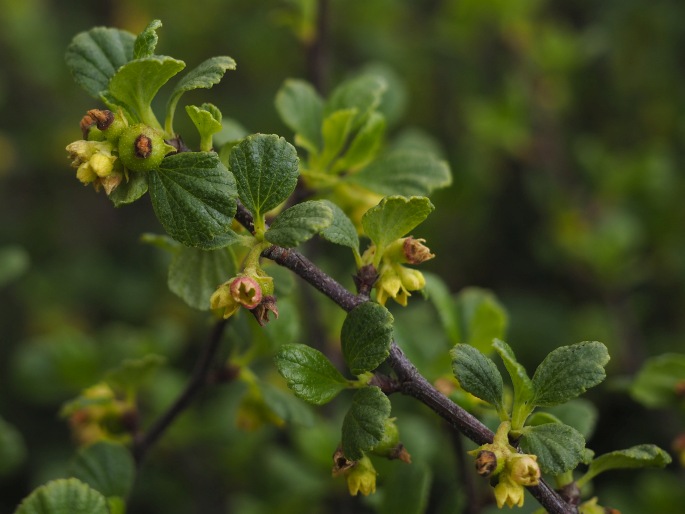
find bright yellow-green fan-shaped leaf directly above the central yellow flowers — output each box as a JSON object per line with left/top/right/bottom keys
{"left": 362, "top": 196, "right": 435, "bottom": 260}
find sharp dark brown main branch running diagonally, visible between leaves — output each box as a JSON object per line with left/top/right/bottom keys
{"left": 236, "top": 206, "right": 578, "bottom": 514}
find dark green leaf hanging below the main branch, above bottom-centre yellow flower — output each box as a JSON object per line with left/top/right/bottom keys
{"left": 342, "top": 386, "right": 390, "bottom": 460}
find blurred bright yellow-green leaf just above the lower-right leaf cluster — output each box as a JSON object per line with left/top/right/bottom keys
{"left": 459, "top": 287, "right": 507, "bottom": 353}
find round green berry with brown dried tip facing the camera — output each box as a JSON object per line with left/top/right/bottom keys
{"left": 119, "top": 123, "right": 175, "bottom": 172}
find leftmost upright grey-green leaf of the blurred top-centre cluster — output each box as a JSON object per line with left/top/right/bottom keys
{"left": 276, "top": 79, "right": 323, "bottom": 153}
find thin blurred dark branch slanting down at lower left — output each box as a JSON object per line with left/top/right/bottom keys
{"left": 133, "top": 319, "right": 228, "bottom": 465}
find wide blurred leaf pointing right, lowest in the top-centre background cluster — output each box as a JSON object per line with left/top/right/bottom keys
{"left": 345, "top": 149, "right": 452, "bottom": 196}
